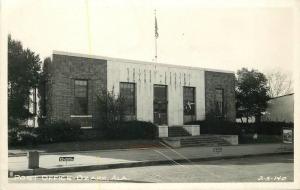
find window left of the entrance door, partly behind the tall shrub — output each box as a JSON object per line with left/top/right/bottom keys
{"left": 120, "top": 82, "right": 136, "bottom": 115}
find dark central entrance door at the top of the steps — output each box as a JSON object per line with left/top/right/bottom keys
{"left": 153, "top": 85, "right": 168, "bottom": 125}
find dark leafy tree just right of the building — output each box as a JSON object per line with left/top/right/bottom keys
{"left": 236, "top": 68, "right": 269, "bottom": 123}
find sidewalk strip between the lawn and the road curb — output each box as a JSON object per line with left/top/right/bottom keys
{"left": 8, "top": 144, "right": 293, "bottom": 175}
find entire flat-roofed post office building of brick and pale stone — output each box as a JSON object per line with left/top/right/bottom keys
{"left": 45, "top": 51, "right": 236, "bottom": 127}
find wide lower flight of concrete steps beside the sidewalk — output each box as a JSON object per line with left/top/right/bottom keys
{"left": 180, "top": 135, "right": 231, "bottom": 147}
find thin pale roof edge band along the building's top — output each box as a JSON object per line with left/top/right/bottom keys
{"left": 53, "top": 50, "right": 234, "bottom": 74}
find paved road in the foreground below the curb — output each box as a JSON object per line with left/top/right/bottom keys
{"left": 9, "top": 154, "right": 294, "bottom": 183}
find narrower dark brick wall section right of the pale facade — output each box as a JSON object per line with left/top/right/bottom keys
{"left": 205, "top": 71, "right": 236, "bottom": 121}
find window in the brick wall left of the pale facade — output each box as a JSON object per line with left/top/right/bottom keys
{"left": 73, "top": 80, "right": 88, "bottom": 115}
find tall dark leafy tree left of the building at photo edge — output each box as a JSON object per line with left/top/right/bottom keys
{"left": 8, "top": 35, "right": 40, "bottom": 126}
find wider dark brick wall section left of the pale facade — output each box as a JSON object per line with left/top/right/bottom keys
{"left": 47, "top": 54, "right": 107, "bottom": 124}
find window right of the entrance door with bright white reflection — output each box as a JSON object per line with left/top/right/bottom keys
{"left": 183, "top": 87, "right": 195, "bottom": 115}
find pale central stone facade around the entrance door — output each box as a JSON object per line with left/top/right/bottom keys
{"left": 107, "top": 60, "right": 205, "bottom": 126}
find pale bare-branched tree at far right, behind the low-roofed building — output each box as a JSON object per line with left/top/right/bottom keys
{"left": 267, "top": 71, "right": 293, "bottom": 98}
